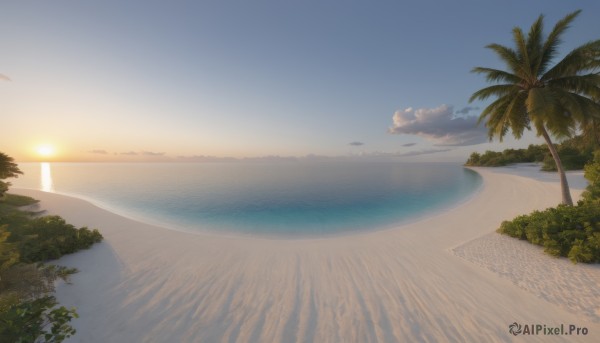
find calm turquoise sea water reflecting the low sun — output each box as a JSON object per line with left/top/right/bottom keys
{"left": 12, "top": 161, "right": 481, "bottom": 237}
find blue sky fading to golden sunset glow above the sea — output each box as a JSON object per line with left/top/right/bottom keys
{"left": 0, "top": 0, "right": 600, "bottom": 162}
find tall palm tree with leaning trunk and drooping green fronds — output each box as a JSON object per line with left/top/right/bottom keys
{"left": 469, "top": 10, "right": 600, "bottom": 205}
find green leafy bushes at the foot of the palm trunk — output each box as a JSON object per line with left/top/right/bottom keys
{"left": 498, "top": 153, "right": 600, "bottom": 263}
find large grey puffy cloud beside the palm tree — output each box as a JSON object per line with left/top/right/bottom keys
{"left": 388, "top": 105, "right": 487, "bottom": 146}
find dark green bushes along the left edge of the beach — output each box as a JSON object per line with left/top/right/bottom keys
{"left": 0, "top": 153, "right": 102, "bottom": 342}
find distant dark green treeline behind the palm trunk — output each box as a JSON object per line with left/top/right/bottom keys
{"left": 465, "top": 136, "right": 597, "bottom": 171}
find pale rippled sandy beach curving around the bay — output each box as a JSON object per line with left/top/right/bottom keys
{"left": 13, "top": 169, "right": 600, "bottom": 342}
